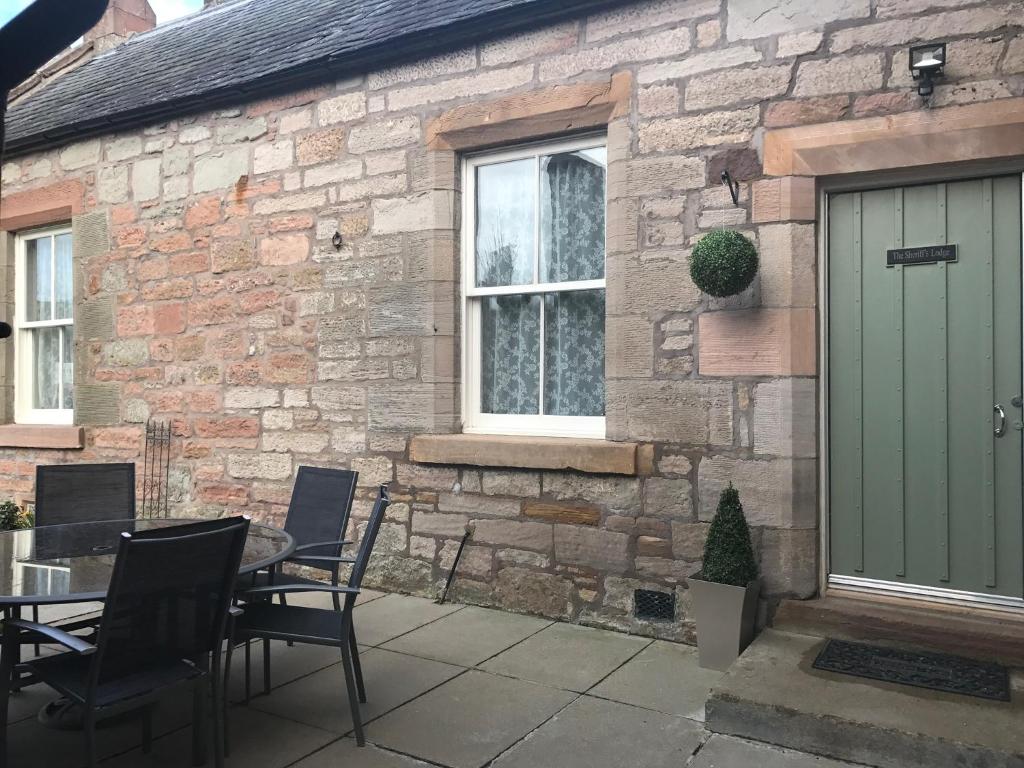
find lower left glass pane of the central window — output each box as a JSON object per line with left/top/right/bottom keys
{"left": 480, "top": 296, "right": 541, "bottom": 414}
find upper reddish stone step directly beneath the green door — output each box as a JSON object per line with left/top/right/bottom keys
{"left": 772, "top": 595, "right": 1024, "bottom": 667}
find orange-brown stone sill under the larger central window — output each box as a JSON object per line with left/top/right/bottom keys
{"left": 409, "top": 434, "right": 637, "bottom": 475}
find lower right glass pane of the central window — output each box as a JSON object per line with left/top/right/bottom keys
{"left": 544, "top": 291, "right": 604, "bottom": 416}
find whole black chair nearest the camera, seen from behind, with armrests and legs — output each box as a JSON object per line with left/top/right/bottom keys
{"left": 0, "top": 517, "right": 249, "bottom": 768}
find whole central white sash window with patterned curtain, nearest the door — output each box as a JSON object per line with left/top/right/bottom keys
{"left": 462, "top": 137, "right": 607, "bottom": 438}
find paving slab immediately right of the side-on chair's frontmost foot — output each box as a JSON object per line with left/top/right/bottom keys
{"left": 367, "top": 670, "right": 575, "bottom": 768}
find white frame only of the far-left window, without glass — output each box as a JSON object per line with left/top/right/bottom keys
{"left": 14, "top": 226, "right": 75, "bottom": 424}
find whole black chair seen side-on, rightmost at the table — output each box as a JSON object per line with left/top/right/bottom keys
{"left": 236, "top": 485, "right": 391, "bottom": 746}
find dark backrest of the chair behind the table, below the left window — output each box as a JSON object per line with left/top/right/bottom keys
{"left": 36, "top": 464, "right": 135, "bottom": 525}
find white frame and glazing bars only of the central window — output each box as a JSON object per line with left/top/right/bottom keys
{"left": 462, "top": 134, "right": 607, "bottom": 439}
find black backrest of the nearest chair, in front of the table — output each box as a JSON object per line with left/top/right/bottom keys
{"left": 90, "top": 517, "right": 249, "bottom": 685}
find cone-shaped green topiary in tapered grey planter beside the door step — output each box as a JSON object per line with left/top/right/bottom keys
{"left": 689, "top": 482, "right": 761, "bottom": 671}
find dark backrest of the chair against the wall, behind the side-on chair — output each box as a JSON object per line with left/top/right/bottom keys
{"left": 285, "top": 467, "right": 359, "bottom": 570}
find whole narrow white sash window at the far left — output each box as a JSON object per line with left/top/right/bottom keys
{"left": 14, "top": 228, "right": 75, "bottom": 424}
